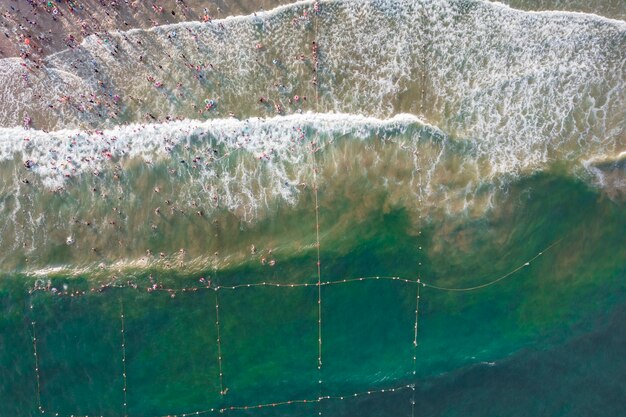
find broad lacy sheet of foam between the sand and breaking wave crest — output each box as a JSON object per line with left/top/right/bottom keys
{"left": 0, "top": 0, "right": 626, "bottom": 180}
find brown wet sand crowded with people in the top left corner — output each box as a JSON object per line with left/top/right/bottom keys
{"left": 0, "top": 0, "right": 291, "bottom": 60}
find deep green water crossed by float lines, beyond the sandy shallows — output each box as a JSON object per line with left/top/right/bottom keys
{"left": 0, "top": 173, "right": 626, "bottom": 416}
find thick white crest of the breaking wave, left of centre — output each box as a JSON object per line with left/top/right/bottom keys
{"left": 0, "top": 113, "right": 424, "bottom": 187}
